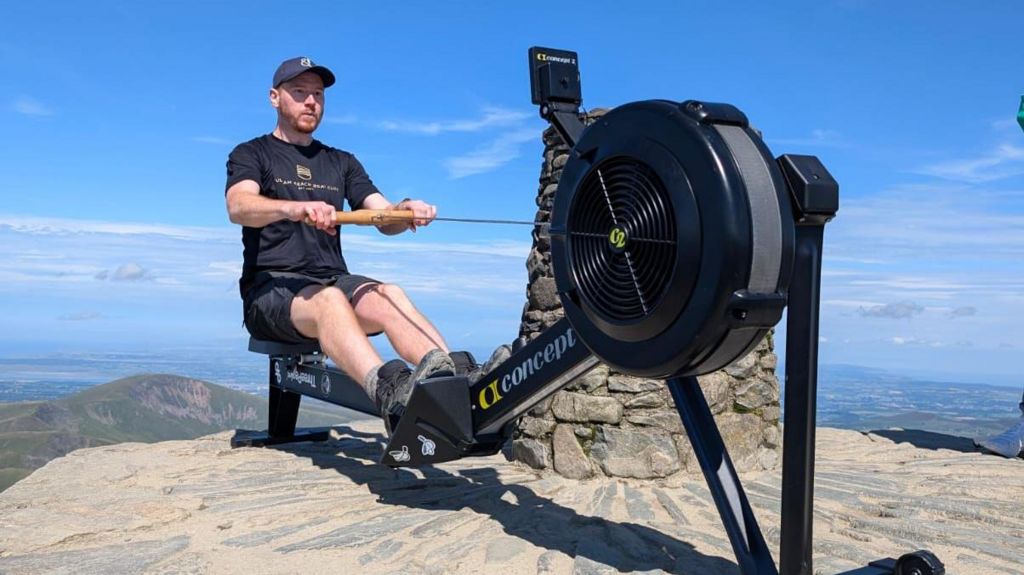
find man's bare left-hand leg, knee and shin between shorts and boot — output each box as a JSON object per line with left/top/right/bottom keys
{"left": 291, "top": 285, "right": 382, "bottom": 385}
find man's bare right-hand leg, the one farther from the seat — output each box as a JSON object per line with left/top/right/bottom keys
{"left": 352, "top": 283, "right": 449, "bottom": 365}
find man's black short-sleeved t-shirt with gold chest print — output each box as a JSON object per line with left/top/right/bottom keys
{"left": 224, "top": 134, "right": 378, "bottom": 298}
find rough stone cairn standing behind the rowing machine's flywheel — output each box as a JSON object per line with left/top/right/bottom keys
{"left": 512, "top": 110, "right": 780, "bottom": 479}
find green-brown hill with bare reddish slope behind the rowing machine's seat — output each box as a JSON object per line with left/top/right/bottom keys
{"left": 0, "top": 373, "right": 368, "bottom": 491}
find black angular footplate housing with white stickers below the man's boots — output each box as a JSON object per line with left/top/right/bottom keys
{"left": 380, "top": 377, "right": 474, "bottom": 468}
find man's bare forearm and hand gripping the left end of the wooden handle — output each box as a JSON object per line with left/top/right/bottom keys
{"left": 225, "top": 180, "right": 337, "bottom": 235}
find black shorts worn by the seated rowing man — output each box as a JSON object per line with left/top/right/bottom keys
{"left": 243, "top": 273, "right": 380, "bottom": 344}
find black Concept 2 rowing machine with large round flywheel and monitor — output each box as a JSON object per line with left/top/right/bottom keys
{"left": 234, "top": 47, "right": 944, "bottom": 575}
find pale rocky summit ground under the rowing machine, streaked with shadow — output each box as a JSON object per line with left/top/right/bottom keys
{"left": 0, "top": 415, "right": 1024, "bottom": 575}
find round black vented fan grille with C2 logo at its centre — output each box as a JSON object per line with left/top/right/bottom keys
{"left": 566, "top": 157, "right": 677, "bottom": 323}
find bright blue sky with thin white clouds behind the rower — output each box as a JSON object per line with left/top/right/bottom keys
{"left": 0, "top": 0, "right": 1024, "bottom": 386}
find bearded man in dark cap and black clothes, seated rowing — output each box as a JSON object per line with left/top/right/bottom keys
{"left": 225, "top": 57, "right": 473, "bottom": 421}
